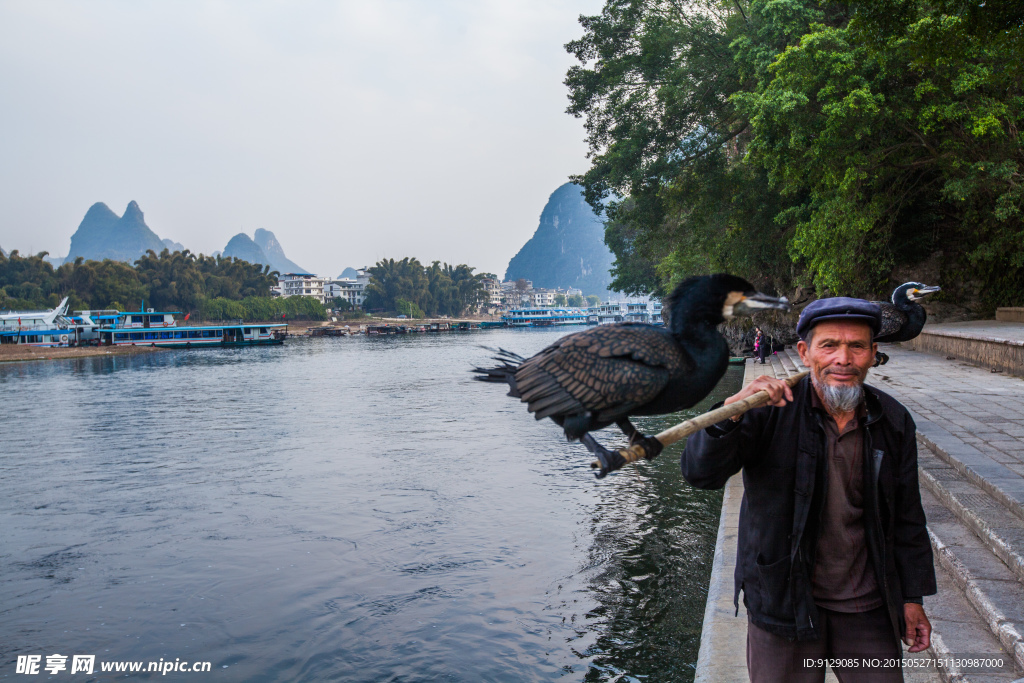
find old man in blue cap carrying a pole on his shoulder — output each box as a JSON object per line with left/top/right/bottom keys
{"left": 681, "top": 297, "right": 936, "bottom": 682}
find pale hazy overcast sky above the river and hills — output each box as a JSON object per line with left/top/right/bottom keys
{"left": 0, "top": 0, "right": 603, "bottom": 275}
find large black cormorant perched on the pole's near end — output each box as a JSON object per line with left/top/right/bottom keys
{"left": 473, "top": 274, "right": 790, "bottom": 473}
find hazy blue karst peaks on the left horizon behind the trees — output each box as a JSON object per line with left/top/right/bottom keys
{"left": 47, "top": 202, "right": 305, "bottom": 272}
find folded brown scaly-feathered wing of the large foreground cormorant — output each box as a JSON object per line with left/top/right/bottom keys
{"left": 515, "top": 323, "right": 693, "bottom": 422}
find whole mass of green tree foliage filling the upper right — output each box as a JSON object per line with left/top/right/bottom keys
{"left": 566, "top": 0, "right": 1024, "bottom": 305}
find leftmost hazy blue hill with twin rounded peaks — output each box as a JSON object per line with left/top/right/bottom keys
{"left": 65, "top": 202, "right": 164, "bottom": 263}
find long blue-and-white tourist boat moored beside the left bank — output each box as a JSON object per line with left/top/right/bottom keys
{"left": 98, "top": 308, "right": 288, "bottom": 348}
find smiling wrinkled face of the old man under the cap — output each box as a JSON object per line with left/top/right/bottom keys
{"left": 797, "top": 321, "right": 879, "bottom": 386}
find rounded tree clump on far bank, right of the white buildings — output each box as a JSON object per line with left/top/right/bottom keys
{"left": 364, "top": 257, "right": 486, "bottom": 316}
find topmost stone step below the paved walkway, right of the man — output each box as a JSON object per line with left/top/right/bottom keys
{"left": 918, "top": 447, "right": 1024, "bottom": 589}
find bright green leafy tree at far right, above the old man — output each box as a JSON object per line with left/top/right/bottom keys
{"left": 734, "top": 0, "right": 1024, "bottom": 305}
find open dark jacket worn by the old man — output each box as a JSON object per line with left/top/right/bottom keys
{"left": 681, "top": 378, "right": 936, "bottom": 651}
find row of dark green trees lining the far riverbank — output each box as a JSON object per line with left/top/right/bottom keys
{"left": 0, "top": 249, "right": 485, "bottom": 321}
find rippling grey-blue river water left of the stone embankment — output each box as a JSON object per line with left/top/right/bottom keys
{"left": 0, "top": 330, "right": 740, "bottom": 681}
